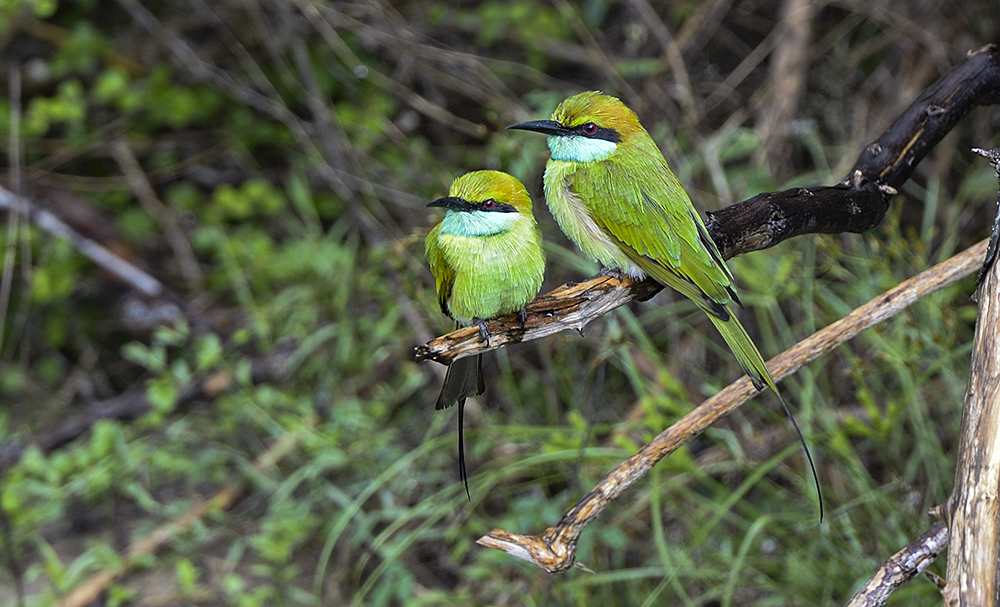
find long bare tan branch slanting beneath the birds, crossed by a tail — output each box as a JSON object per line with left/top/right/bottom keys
{"left": 476, "top": 240, "right": 987, "bottom": 573}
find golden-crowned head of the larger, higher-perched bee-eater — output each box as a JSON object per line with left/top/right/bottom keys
{"left": 507, "top": 91, "right": 645, "bottom": 162}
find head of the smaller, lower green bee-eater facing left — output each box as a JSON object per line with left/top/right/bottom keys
{"left": 427, "top": 171, "right": 534, "bottom": 236}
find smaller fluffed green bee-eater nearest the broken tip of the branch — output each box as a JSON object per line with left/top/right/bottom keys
{"left": 426, "top": 171, "right": 545, "bottom": 499}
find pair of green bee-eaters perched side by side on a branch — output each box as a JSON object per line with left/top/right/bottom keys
{"left": 427, "top": 92, "right": 822, "bottom": 507}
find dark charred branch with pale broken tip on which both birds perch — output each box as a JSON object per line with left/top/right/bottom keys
{"left": 416, "top": 45, "right": 1000, "bottom": 364}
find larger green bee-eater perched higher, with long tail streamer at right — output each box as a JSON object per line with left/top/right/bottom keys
{"left": 507, "top": 92, "right": 822, "bottom": 512}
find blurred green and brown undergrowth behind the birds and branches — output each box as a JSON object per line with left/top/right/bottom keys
{"left": 0, "top": 0, "right": 1000, "bottom": 606}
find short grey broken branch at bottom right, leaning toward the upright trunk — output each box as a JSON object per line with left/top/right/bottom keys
{"left": 847, "top": 522, "right": 948, "bottom": 607}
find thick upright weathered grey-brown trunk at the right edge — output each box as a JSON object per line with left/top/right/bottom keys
{"left": 944, "top": 150, "right": 1000, "bottom": 607}
